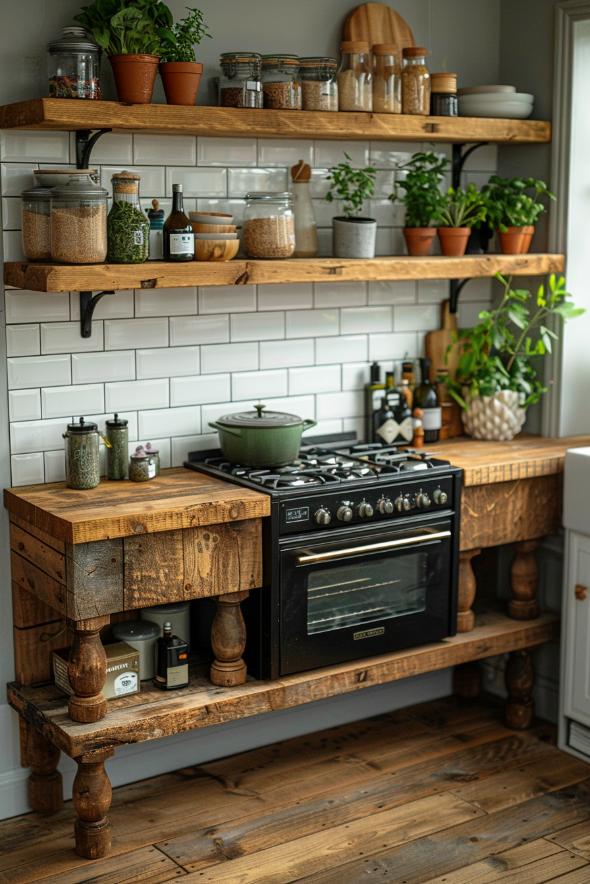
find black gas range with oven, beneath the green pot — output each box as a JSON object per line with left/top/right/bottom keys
{"left": 185, "top": 434, "right": 462, "bottom": 678}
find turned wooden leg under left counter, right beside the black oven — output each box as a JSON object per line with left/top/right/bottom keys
{"left": 211, "top": 591, "right": 249, "bottom": 688}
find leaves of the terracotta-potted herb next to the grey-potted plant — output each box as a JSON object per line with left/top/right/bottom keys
{"left": 389, "top": 152, "right": 449, "bottom": 227}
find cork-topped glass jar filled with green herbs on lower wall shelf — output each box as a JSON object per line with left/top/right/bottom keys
{"left": 107, "top": 172, "right": 150, "bottom": 264}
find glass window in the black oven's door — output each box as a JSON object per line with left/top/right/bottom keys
{"left": 307, "top": 551, "right": 429, "bottom": 635}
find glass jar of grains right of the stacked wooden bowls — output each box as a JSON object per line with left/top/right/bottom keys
{"left": 242, "top": 193, "right": 295, "bottom": 258}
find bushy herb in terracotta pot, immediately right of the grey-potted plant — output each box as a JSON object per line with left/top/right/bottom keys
{"left": 389, "top": 152, "right": 449, "bottom": 257}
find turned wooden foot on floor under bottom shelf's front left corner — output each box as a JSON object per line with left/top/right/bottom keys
{"left": 72, "top": 749, "right": 113, "bottom": 859}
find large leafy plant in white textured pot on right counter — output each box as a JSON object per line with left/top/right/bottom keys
{"left": 445, "top": 273, "right": 585, "bottom": 440}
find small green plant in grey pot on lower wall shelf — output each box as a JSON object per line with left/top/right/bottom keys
{"left": 326, "top": 153, "right": 377, "bottom": 258}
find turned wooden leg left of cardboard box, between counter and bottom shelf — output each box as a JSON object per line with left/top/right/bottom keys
{"left": 68, "top": 617, "right": 110, "bottom": 724}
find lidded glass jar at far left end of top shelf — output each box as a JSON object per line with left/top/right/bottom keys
{"left": 47, "top": 28, "right": 101, "bottom": 99}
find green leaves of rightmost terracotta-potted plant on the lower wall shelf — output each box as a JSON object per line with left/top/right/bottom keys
{"left": 482, "top": 175, "right": 555, "bottom": 233}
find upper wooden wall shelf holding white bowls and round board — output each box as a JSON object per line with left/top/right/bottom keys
{"left": 0, "top": 98, "right": 551, "bottom": 144}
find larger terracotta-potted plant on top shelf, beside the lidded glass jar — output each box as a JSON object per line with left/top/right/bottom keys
{"left": 75, "top": 0, "right": 172, "bottom": 104}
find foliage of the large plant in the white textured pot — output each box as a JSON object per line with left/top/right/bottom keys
{"left": 445, "top": 273, "right": 585, "bottom": 409}
